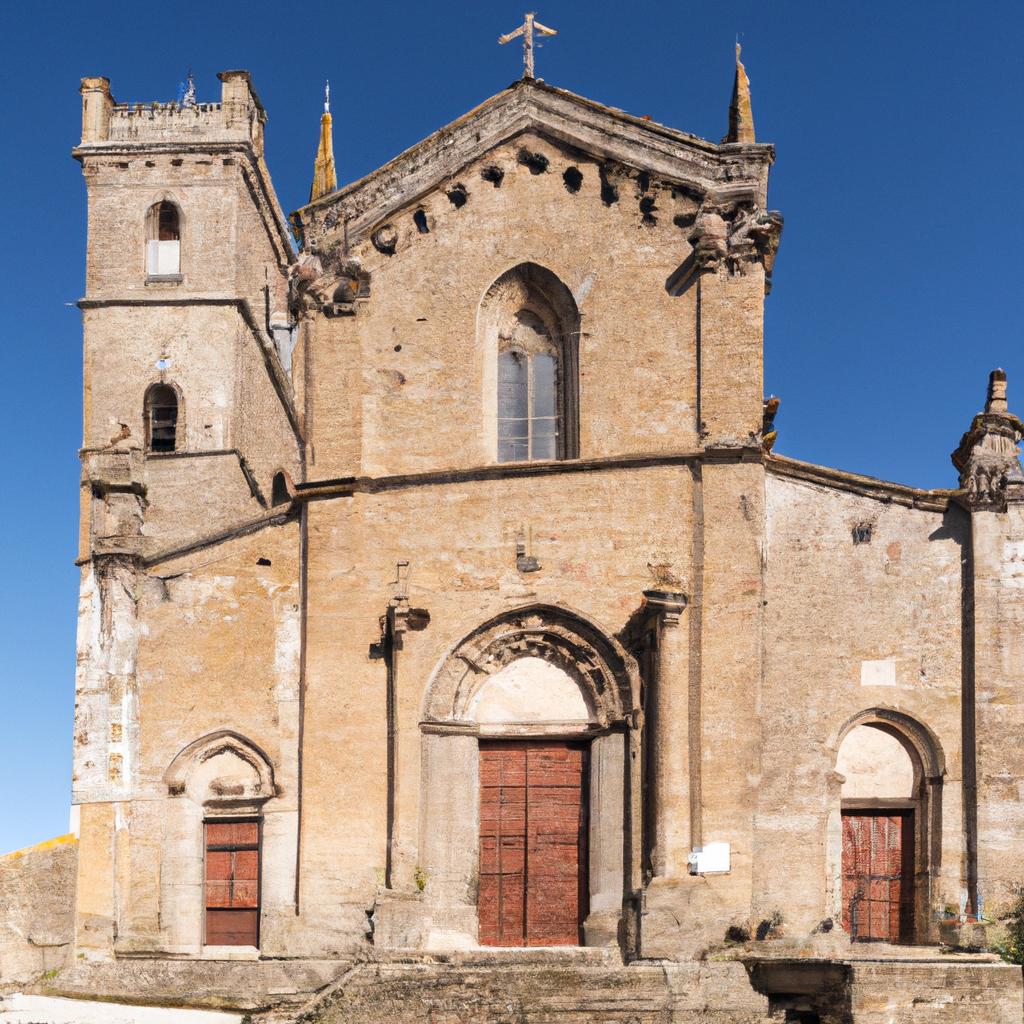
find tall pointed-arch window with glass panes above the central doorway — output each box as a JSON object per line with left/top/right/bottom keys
{"left": 479, "top": 263, "right": 580, "bottom": 462}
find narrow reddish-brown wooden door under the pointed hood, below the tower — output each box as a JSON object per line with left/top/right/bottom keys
{"left": 205, "top": 821, "right": 260, "bottom": 946}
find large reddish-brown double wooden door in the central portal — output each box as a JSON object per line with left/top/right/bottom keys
{"left": 479, "top": 740, "right": 587, "bottom": 946}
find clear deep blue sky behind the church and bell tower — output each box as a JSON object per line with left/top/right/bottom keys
{"left": 0, "top": 0, "right": 1024, "bottom": 852}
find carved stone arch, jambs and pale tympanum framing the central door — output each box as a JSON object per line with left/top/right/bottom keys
{"left": 420, "top": 605, "right": 639, "bottom": 948}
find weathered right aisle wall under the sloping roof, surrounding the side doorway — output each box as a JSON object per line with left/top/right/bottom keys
{"left": 754, "top": 472, "right": 969, "bottom": 935}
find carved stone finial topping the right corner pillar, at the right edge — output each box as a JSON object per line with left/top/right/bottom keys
{"left": 952, "top": 370, "right": 1024, "bottom": 508}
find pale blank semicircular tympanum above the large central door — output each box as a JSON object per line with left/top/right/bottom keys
{"left": 468, "top": 657, "right": 593, "bottom": 733}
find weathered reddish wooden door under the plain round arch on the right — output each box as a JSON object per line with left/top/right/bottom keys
{"left": 843, "top": 811, "right": 913, "bottom": 942}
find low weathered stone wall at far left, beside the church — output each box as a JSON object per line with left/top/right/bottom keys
{"left": 0, "top": 836, "right": 78, "bottom": 985}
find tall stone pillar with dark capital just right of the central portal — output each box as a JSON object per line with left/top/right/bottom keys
{"left": 643, "top": 590, "right": 690, "bottom": 878}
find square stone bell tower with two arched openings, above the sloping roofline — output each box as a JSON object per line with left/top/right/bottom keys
{"left": 74, "top": 71, "right": 299, "bottom": 556}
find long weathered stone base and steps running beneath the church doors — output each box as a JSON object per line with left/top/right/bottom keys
{"left": 49, "top": 948, "right": 1024, "bottom": 1024}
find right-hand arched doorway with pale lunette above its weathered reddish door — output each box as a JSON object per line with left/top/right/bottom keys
{"left": 833, "top": 710, "right": 942, "bottom": 943}
